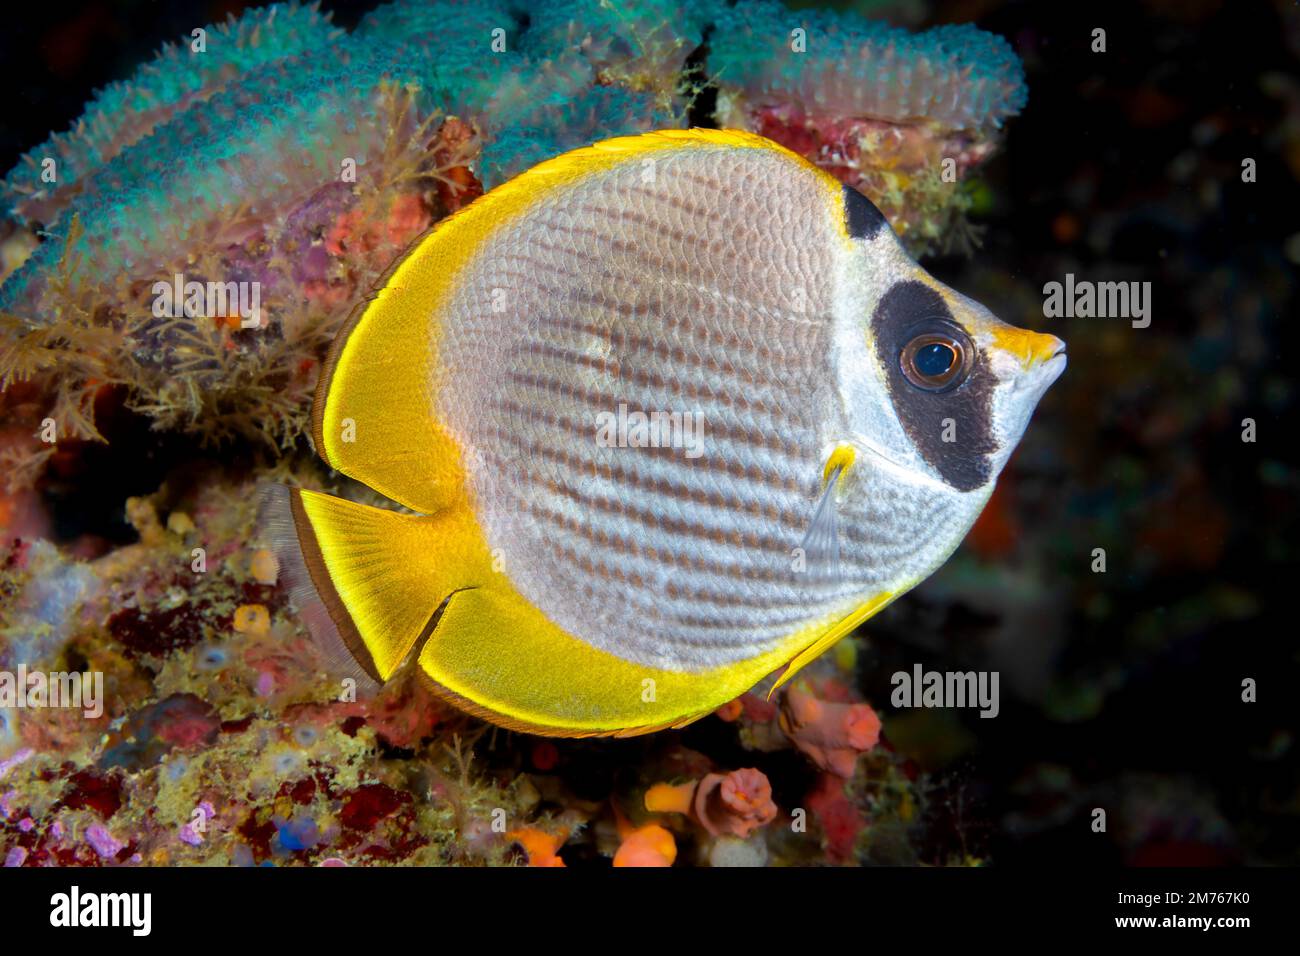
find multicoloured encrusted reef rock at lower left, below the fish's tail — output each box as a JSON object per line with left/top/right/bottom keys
{"left": 0, "top": 470, "right": 536, "bottom": 865}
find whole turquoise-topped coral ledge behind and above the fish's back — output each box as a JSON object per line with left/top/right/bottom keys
{"left": 0, "top": 0, "right": 1024, "bottom": 445}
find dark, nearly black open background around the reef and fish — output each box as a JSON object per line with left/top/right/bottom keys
{"left": 0, "top": 0, "right": 1300, "bottom": 866}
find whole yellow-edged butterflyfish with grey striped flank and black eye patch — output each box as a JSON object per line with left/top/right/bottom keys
{"left": 266, "top": 130, "right": 1065, "bottom": 735}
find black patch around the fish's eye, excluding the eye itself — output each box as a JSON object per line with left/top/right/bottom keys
{"left": 871, "top": 280, "right": 997, "bottom": 492}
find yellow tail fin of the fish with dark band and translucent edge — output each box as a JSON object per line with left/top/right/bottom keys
{"left": 268, "top": 489, "right": 484, "bottom": 682}
